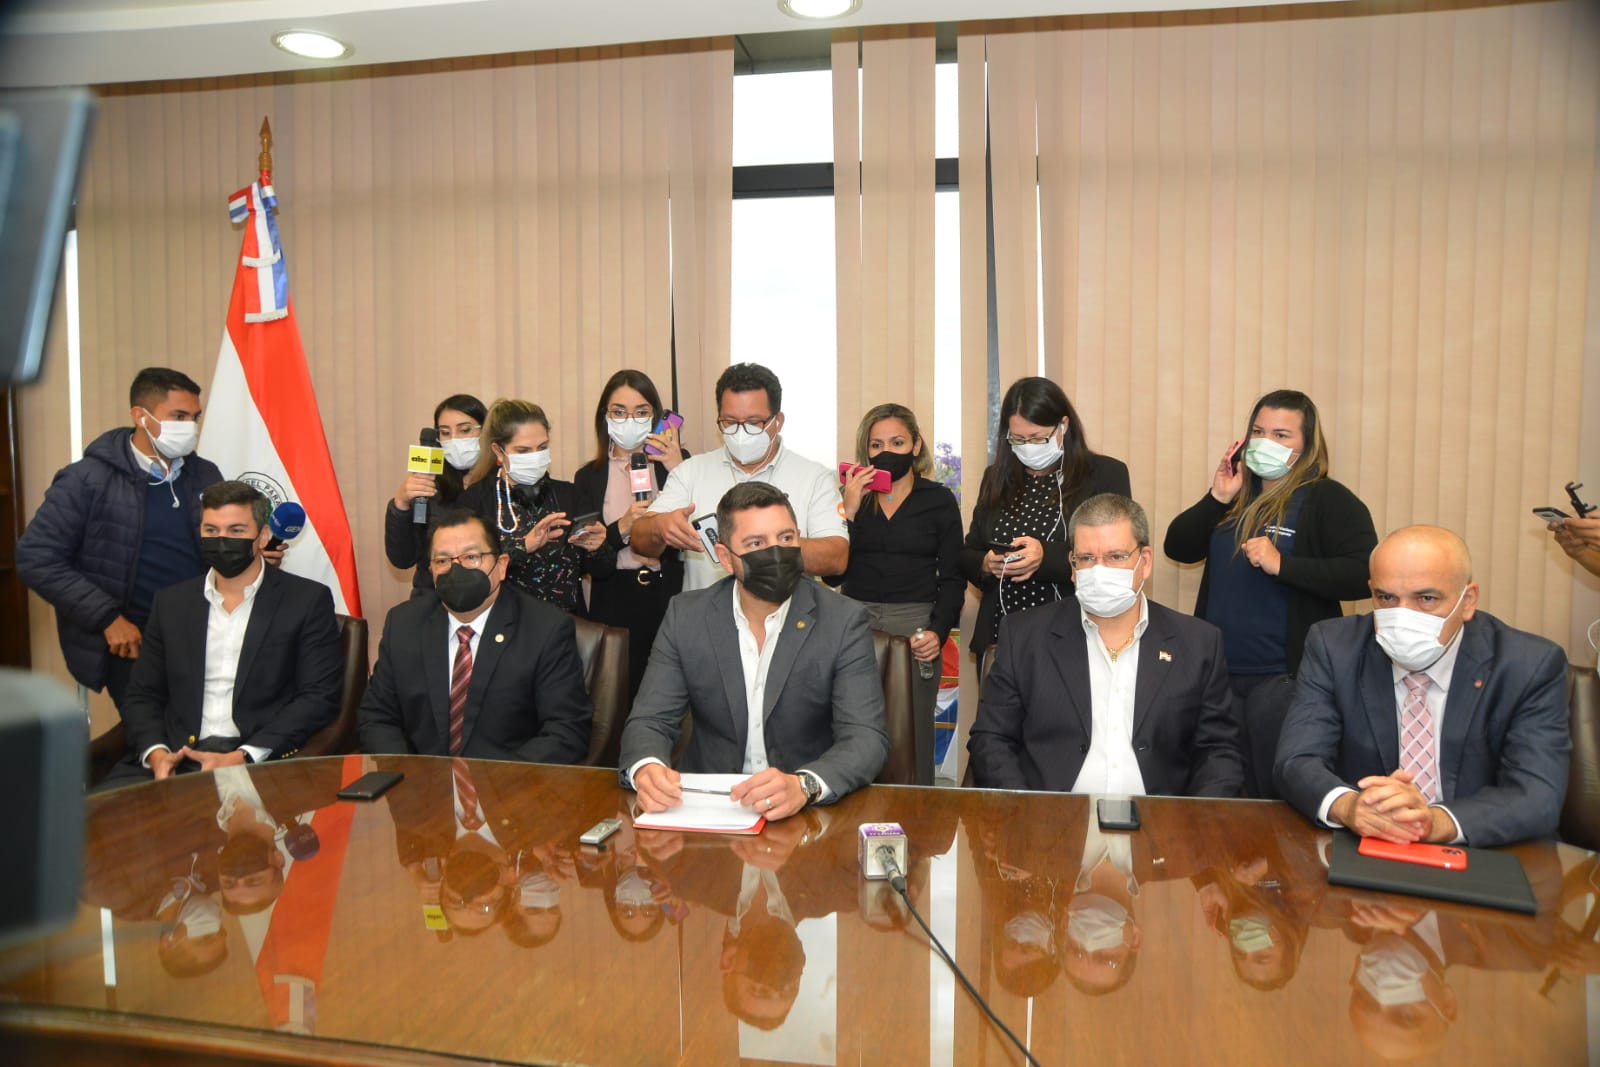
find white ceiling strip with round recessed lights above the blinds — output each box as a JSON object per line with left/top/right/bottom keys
{"left": 0, "top": 0, "right": 1324, "bottom": 86}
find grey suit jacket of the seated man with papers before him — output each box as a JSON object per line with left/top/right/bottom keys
{"left": 619, "top": 577, "right": 890, "bottom": 798}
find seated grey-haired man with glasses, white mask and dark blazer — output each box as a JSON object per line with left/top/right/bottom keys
{"left": 966, "top": 493, "right": 1245, "bottom": 797}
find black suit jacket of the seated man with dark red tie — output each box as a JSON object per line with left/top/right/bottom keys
{"left": 360, "top": 582, "right": 594, "bottom": 763}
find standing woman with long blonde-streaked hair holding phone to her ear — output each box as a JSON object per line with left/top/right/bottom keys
{"left": 1163, "top": 389, "right": 1378, "bottom": 699}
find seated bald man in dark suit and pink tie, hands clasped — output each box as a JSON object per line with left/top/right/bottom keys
{"left": 1274, "top": 526, "right": 1571, "bottom": 846}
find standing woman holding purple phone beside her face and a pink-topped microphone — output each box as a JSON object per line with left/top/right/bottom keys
{"left": 573, "top": 370, "right": 688, "bottom": 697}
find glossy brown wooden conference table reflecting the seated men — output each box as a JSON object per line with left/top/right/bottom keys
{"left": 0, "top": 757, "right": 1600, "bottom": 1065}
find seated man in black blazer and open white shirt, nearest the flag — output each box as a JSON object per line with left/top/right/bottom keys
{"left": 102, "top": 482, "right": 344, "bottom": 787}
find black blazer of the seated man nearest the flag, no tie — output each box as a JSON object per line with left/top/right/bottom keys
{"left": 122, "top": 563, "right": 344, "bottom": 758}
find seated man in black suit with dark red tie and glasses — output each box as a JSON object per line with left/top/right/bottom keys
{"left": 360, "top": 509, "right": 594, "bottom": 763}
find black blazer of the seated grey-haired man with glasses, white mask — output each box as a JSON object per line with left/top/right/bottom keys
{"left": 966, "top": 597, "right": 1245, "bottom": 797}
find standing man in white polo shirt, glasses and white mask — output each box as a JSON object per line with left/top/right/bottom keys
{"left": 629, "top": 363, "right": 850, "bottom": 592}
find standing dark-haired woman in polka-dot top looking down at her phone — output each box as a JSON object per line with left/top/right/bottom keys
{"left": 962, "top": 378, "right": 1133, "bottom": 654}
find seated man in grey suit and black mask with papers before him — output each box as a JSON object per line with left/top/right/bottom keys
{"left": 619, "top": 482, "right": 890, "bottom": 819}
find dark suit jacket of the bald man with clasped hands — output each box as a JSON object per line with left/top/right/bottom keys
{"left": 1274, "top": 611, "right": 1571, "bottom": 848}
